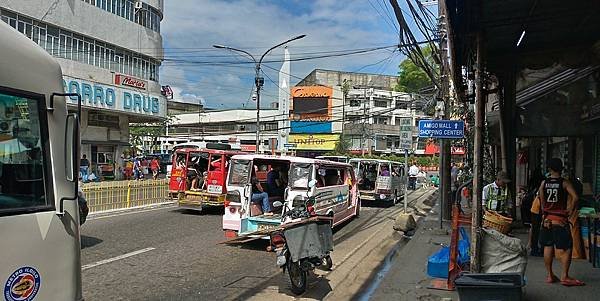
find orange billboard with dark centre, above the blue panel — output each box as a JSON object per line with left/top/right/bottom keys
{"left": 290, "top": 86, "right": 333, "bottom": 121}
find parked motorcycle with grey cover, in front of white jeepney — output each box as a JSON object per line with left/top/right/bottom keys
{"left": 270, "top": 178, "right": 333, "bottom": 295}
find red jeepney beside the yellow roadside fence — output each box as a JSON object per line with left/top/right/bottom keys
{"left": 169, "top": 148, "right": 243, "bottom": 210}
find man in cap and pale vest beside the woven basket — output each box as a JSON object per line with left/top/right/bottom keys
{"left": 482, "top": 171, "right": 512, "bottom": 217}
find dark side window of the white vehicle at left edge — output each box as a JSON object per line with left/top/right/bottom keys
{"left": 0, "top": 93, "right": 51, "bottom": 211}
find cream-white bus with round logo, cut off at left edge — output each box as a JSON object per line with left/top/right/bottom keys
{"left": 0, "top": 22, "right": 83, "bottom": 301}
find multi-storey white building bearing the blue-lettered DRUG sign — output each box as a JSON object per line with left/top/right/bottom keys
{"left": 0, "top": 0, "right": 167, "bottom": 175}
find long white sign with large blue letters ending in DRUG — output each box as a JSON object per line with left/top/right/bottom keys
{"left": 63, "top": 76, "right": 167, "bottom": 118}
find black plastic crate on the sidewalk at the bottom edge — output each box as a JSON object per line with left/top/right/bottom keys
{"left": 454, "top": 273, "right": 524, "bottom": 301}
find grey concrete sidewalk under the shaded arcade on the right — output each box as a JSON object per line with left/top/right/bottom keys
{"left": 370, "top": 203, "right": 600, "bottom": 300}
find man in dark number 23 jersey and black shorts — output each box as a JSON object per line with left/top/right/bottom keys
{"left": 539, "top": 158, "right": 585, "bottom": 286}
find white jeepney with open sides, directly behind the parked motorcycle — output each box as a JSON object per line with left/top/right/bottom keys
{"left": 223, "top": 155, "right": 360, "bottom": 237}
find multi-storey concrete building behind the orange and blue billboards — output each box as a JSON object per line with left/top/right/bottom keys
{"left": 290, "top": 69, "right": 431, "bottom": 156}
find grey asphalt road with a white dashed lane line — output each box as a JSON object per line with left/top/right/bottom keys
{"left": 81, "top": 198, "right": 392, "bottom": 300}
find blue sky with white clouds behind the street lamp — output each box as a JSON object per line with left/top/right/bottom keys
{"left": 160, "top": 0, "right": 434, "bottom": 109}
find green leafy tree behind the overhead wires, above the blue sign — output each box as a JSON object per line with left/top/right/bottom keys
{"left": 394, "top": 46, "right": 439, "bottom": 93}
